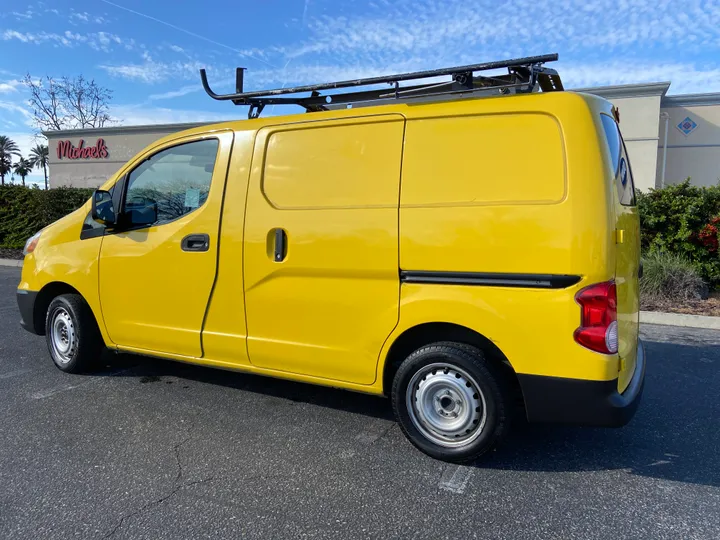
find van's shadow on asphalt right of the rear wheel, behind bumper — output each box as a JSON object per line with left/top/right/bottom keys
{"left": 484, "top": 340, "right": 720, "bottom": 487}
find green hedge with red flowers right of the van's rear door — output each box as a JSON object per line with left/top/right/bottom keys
{"left": 638, "top": 179, "right": 720, "bottom": 289}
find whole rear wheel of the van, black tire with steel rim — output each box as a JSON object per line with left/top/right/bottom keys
{"left": 391, "top": 342, "right": 513, "bottom": 463}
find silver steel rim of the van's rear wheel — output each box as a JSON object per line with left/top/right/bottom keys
{"left": 405, "top": 362, "right": 487, "bottom": 448}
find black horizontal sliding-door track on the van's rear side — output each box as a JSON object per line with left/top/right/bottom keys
{"left": 400, "top": 270, "right": 581, "bottom": 289}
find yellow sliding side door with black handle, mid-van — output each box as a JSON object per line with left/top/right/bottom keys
{"left": 244, "top": 115, "right": 405, "bottom": 385}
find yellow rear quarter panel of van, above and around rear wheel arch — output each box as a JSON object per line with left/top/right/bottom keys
{"left": 398, "top": 93, "right": 618, "bottom": 380}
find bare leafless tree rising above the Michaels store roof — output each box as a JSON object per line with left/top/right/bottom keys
{"left": 23, "top": 73, "right": 113, "bottom": 130}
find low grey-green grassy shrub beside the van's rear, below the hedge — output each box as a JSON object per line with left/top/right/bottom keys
{"left": 640, "top": 251, "right": 707, "bottom": 302}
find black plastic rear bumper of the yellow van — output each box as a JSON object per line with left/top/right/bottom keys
{"left": 518, "top": 340, "right": 646, "bottom": 427}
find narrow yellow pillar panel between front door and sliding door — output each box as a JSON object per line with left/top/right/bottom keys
{"left": 202, "top": 131, "right": 255, "bottom": 364}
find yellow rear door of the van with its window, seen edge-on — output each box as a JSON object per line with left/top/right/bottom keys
{"left": 601, "top": 114, "right": 640, "bottom": 392}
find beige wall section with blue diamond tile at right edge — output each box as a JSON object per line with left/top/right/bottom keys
{"left": 657, "top": 98, "right": 720, "bottom": 186}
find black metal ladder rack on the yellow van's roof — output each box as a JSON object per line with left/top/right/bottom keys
{"left": 200, "top": 54, "right": 563, "bottom": 118}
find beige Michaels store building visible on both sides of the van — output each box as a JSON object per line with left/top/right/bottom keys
{"left": 44, "top": 82, "right": 720, "bottom": 191}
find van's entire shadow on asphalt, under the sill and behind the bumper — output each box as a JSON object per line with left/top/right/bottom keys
{"left": 98, "top": 341, "right": 720, "bottom": 486}
